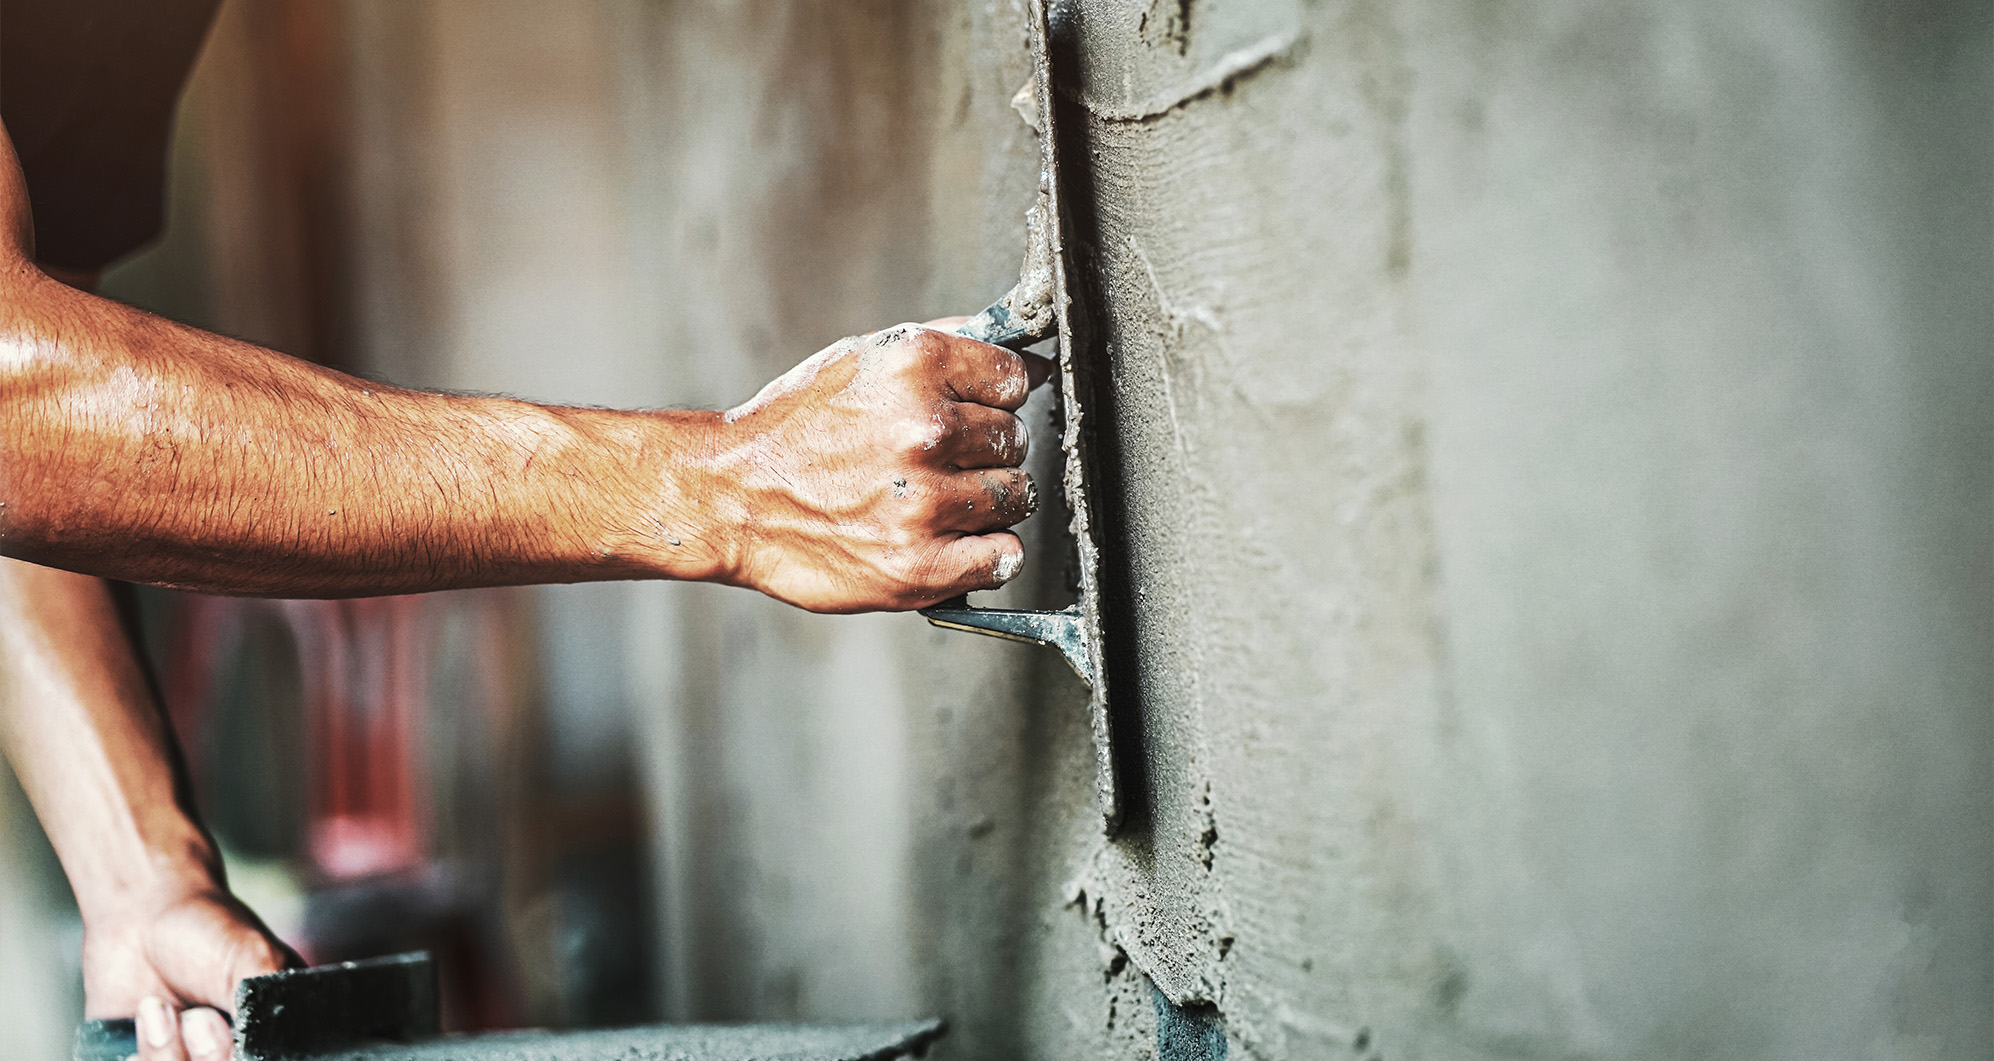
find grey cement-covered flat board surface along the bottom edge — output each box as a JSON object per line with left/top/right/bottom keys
{"left": 299, "top": 1021, "right": 941, "bottom": 1061}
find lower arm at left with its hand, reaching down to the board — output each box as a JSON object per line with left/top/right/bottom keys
{"left": 0, "top": 560, "right": 291, "bottom": 1061}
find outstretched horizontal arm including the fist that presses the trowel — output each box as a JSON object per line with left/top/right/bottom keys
{"left": 0, "top": 119, "right": 1039, "bottom": 610}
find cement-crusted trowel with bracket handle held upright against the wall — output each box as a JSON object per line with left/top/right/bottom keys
{"left": 921, "top": 0, "right": 1123, "bottom": 832}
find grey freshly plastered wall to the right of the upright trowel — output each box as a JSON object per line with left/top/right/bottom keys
{"left": 1059, "top": 0, "right": 1994, "bottom": 1057}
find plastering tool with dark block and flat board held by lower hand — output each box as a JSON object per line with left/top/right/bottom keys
{"left": 76, "top": 953, "right": 941, "bottom": 1061}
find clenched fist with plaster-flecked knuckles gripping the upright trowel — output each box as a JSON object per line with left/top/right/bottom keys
{"left": 718, "top": 321, "right": 1051, "bottom": 612}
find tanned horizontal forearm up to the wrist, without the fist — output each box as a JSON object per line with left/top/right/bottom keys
{"left": 0, "top": 271, "right": 726, "bottom": 596}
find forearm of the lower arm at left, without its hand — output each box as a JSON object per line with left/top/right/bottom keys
{"left": 0, "top": 560, "right": 219, "bottom": 923}
